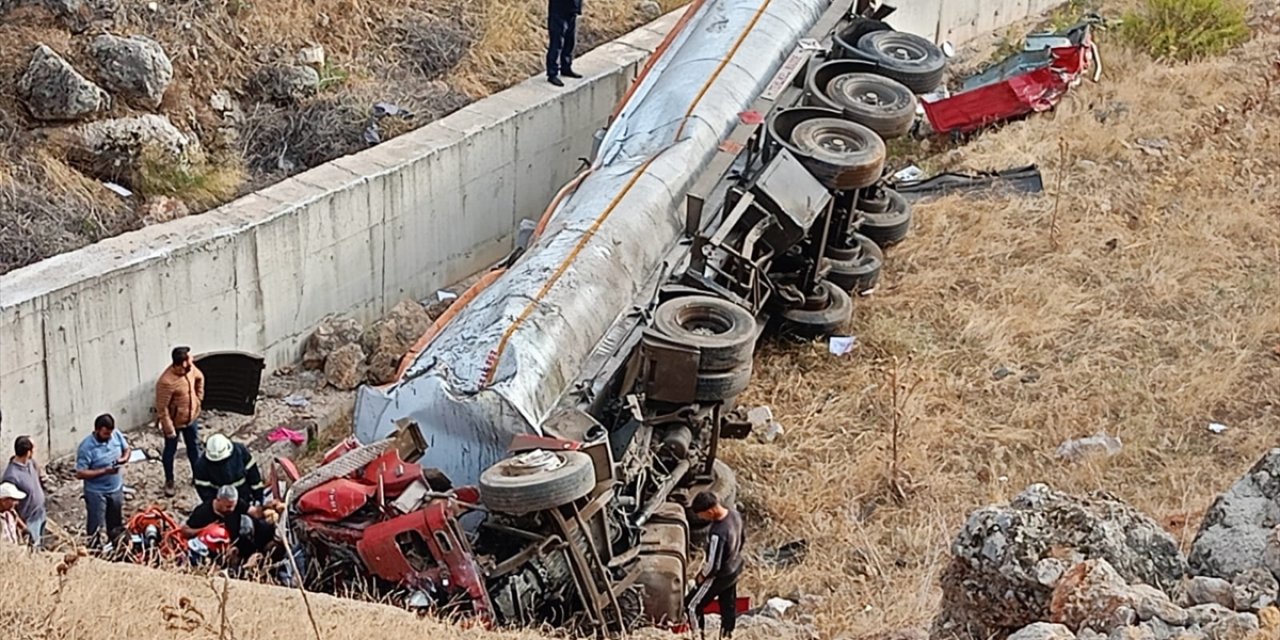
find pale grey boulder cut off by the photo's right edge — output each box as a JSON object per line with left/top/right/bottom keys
{"left": 1189, "top": 448, "right": 1280, "bottom": 580}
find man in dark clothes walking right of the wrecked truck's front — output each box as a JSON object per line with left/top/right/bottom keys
{"left": 685, "top": 492, "right": 745, "bottom": 637}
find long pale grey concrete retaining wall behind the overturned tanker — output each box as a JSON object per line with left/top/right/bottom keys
{"left": 0, "top": 0, "right": 1053, "bottom": 454}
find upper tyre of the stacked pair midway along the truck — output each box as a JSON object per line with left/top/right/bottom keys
{"left": 653, "top": 296, "right": 756, "bottom": 371}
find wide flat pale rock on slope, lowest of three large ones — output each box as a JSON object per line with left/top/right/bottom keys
{"left": 74, "top": 114, "right": 200, "bottom": 182}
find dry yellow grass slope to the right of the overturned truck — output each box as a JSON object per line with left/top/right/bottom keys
{"left": 726, "top": 23, "right": 1280, "bottom": 637}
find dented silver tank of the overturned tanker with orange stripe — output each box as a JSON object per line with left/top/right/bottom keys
{"left": 355, "top": 0, "right": 829, "bottom": 485}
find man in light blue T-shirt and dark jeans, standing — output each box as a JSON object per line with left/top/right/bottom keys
{"left": 76, "top": 413, "right": 131, "bottom": 547}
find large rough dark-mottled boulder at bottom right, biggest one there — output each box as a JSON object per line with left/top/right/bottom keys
{"left": 932, "top": 484, "right": 1187, "bottom": 640}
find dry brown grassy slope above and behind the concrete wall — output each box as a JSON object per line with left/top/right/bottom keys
{"left": 0, "top": 0, "right": 681, "bottom": 273}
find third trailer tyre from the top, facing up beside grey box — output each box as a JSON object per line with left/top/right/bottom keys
{"left": 791, "top": 118, "right": 884, "bottom": 191}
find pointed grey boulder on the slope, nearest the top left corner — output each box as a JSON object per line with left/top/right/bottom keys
{"left": 18, "top": 45, "right": 111, "bottom": 120}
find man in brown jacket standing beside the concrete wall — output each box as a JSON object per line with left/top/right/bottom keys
{"left": 156, "top": 347, "right": 205, "bottom": 498}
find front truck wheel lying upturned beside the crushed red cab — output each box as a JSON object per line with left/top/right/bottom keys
{"left": 480, "top": 449, "right": 595, "bottom": 515}
